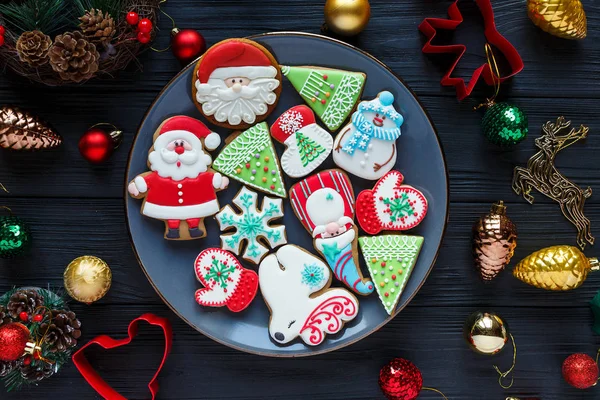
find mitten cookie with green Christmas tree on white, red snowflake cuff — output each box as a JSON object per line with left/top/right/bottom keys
{"left": 271, "top": 106, "right": 333, "bottom": 178}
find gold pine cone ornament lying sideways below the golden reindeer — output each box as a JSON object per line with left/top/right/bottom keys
{"left": 513, "top": 245, "right": 600, "bottom": 291}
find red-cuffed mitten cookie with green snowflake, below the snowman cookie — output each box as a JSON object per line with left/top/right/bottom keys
{"left": 356, "top": 171, "right": 427, "bottom": 235}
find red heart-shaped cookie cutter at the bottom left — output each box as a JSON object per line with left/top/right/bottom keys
{"left": 73, "top": 314, "right": 173, "bottom": 400}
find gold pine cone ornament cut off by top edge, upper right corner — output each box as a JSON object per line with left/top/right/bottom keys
{"left": 527, "top": 0, "right": 587, "bottom": 39}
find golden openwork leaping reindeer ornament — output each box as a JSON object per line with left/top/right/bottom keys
{"left": 512, "top": 117, "right": 594, "bottom": 249}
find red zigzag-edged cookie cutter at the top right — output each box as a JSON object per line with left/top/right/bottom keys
{"left": 419, "top": 0, "right": 524, "bottom": 100}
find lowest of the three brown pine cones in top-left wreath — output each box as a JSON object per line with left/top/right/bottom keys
{"left": 50, "top": 31, "right": 100, "bottom": 83}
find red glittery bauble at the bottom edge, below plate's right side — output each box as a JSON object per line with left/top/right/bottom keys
{"left": 379, "top": 358, "right": 423, "bottom": 400}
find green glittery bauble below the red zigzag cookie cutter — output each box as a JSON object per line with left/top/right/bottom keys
{"left": 483, "top": 103, "right": 528, "bottom": 146}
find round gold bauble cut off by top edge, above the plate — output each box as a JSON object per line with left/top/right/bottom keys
{"left": 325, "top": 0, "right": 371, "bottom": 36}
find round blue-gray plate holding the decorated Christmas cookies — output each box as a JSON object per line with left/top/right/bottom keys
{"left": 125, "top": 33, "right": 448, "bottom": 357}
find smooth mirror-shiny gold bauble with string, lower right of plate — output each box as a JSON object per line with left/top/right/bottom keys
{"left": 464, "top": 311, "right": 509, "bottom": 355}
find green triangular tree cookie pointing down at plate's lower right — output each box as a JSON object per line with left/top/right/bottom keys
{"left": 358, "top": 235, "right": 423, "bottom": 315}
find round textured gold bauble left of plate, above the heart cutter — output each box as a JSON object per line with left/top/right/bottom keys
{"left": 64, "top": 256, "right": 112, "bottom": 304}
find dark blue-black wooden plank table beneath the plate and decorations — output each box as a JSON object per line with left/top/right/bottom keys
{"left": 0, "top": 0, "right": 600, "bottom": 400}
